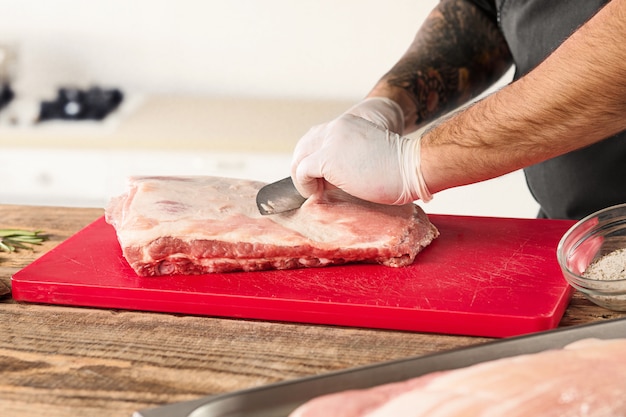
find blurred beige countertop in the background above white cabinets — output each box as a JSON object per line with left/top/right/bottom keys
{"left": 0, "top": 95, "right": 352, "bottom": 153}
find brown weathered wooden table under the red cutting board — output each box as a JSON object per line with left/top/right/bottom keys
{"left": 0, "top": 205, "right": 626, "bottom": 417}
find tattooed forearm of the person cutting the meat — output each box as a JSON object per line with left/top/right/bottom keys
{"left": 379, "top": 0, "right": 511, "bottom": 126}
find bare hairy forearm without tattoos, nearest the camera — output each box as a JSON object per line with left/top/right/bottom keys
{"left": 422, "top": 0, "right": 626, "bottom": 192}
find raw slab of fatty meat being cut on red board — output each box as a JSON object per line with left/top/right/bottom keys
{"left": 105, "top": 176, "right": 439, "bottom": 276}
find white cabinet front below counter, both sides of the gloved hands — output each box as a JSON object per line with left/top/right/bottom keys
{"left": 0, "top": 148, "right": 538, "bottom": 217}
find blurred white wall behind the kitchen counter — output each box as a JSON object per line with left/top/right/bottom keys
{"left": 0, "top": 0, "right": 437, "bottom": 99}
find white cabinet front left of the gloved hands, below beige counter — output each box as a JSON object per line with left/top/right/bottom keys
{"left": 0, "top": 148, "right": 291, "bottom": 207}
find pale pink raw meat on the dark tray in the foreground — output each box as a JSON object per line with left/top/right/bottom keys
{"left": 290, "top": 339, "right": 626, "bottom": 417}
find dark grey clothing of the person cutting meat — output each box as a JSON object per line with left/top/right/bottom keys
{"left": 468, "top": 0, "right": 626, "bottom": 219}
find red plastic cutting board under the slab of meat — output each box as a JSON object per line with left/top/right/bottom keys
{"left": 12, "top": 214, "right": 574, "bottom": 337}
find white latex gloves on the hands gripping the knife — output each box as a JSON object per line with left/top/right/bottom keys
{"left": 291, "top": 98, "right": 432, "bottom": 204}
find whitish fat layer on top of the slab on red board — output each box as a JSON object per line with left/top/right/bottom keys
{"left": 111, "top": 177, "right": 420, "bottom": 248}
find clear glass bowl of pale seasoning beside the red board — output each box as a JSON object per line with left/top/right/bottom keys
{"left": 557, "top": 204, "right": 626, "bottom": 311}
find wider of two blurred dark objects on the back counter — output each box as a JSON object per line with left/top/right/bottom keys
{"left": 38, "top": 87, "right": 124, "bottom": 122}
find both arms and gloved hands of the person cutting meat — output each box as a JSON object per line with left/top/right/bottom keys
{"left": 292, "top": 0, "right": 626, "bottom": 204}
